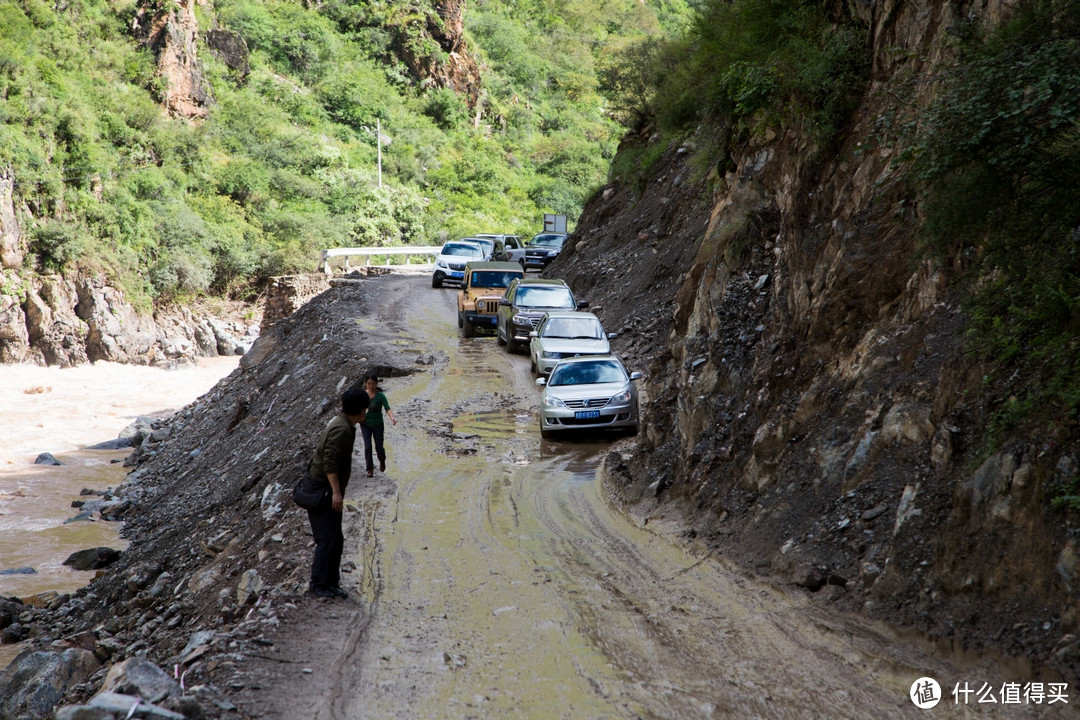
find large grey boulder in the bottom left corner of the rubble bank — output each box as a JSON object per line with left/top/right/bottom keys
{"left": 0, "top": 648, "right": 100, "bottom": 720}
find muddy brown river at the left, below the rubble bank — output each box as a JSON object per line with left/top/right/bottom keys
{"left": 0, "top": 357, "right": 239, "bottom": 667}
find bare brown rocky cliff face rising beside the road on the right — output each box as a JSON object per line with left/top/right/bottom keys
{"left": 548, "top": 2, "right": 1080, "bottom": 677}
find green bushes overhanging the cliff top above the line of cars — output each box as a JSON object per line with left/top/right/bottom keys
{"left": 636, "top": 0, "right": 869, "bottom": 149}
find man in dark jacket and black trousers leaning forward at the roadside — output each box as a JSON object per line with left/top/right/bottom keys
{"left": 308, "top": 388, "right": 369, "bottom": 598}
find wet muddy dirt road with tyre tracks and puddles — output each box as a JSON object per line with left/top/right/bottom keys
{"left": 238, "top": 276, "right": 1054, "bottom": 720}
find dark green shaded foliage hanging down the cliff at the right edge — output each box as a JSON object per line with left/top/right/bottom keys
{"left": 907, "top": 0, "right": 1080, "bottom": 455}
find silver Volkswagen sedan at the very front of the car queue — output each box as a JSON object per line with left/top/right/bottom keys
{"left": 537, "top": 355, "right": 642, "bottom": 438}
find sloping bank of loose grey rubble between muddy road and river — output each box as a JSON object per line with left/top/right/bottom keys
{"left": 0, "top": 273, "right": 440, "bottom": 718}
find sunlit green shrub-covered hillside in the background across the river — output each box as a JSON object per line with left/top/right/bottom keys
{"left": 0, "top": 0, "right": 688, "bottom": 341}
